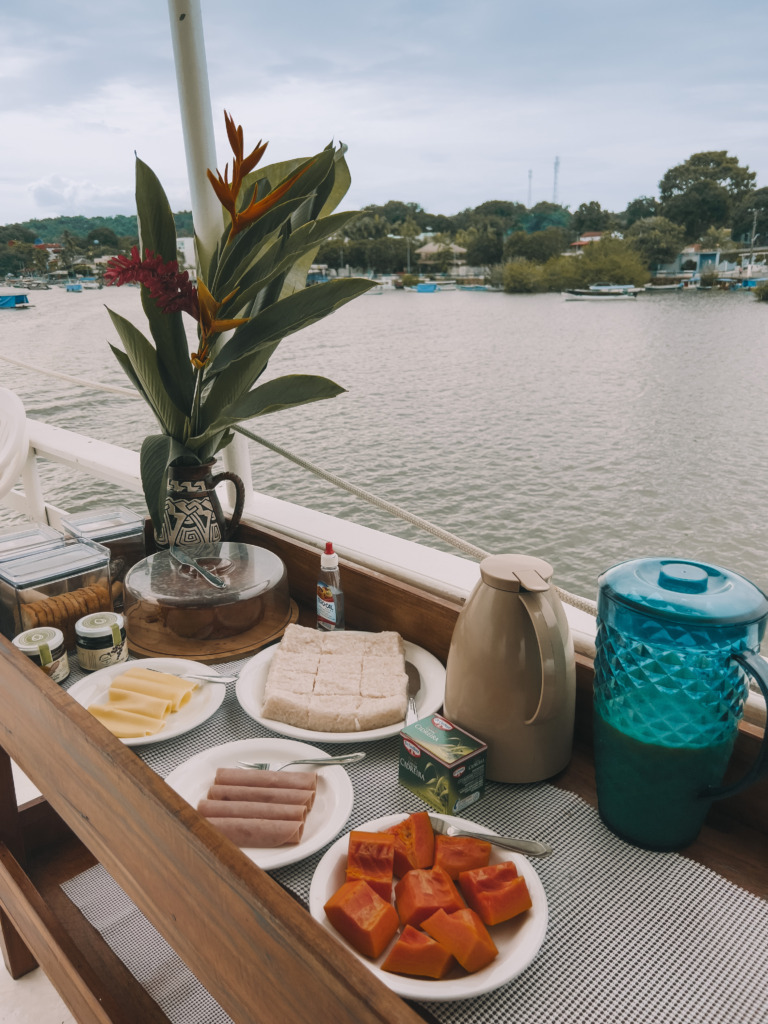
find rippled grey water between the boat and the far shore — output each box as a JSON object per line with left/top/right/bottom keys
{"left": 0, "top": 280, "right": 768, "bottom": 597}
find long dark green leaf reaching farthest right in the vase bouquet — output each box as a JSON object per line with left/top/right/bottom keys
{"left": 214, "top": 278, "right": 375, "bottom": 371}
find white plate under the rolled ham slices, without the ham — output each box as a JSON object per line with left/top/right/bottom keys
{"left": 166, "top": 739, "right": 354, "bottom": 870}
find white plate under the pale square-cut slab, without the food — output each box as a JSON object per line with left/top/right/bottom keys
{"left": 237, "top": 640, "right": 445, "bottom": 743}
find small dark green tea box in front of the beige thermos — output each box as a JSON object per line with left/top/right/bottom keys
{"left": 397, "top": 715, "right": 487, "bottom": 814}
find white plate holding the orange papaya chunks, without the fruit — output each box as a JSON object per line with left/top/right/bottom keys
{"left": 309, "top": 811, "right": 549, "bottom": 1002}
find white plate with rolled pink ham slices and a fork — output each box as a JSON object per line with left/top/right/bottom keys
{"left": 166, "top": 738, "right": 354, "bottom": 870}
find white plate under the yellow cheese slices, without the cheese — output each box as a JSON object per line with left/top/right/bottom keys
{"left": 68, "top": 657, "right": 226, "bottom": 746}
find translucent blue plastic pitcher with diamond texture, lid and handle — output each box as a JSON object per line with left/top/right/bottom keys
{"left": 594, "top": 558, "right": 768, "bottom": 850}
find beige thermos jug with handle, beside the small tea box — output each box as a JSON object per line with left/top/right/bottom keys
{"left": 444, "top": 555, "right": 575, "bottom": 782}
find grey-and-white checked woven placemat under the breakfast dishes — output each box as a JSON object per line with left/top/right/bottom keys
{"left": 62, "top": 665, "right": 768, "bottom": 1024}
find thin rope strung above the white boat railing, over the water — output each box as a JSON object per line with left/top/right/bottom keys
{"left": 0, "top": 354, "right": 597, "bottom": 617}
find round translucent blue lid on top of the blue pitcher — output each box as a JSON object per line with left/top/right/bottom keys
{"left": 598, "top": 558, "right": 768, "bottom": 626}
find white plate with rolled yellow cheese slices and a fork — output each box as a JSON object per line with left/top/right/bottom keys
{"left": 69, "top": 657, "right": 226, "bottom": 746}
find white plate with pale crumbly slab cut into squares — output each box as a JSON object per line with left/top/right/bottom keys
{"left": 237, "top": 625, "right": 445, "bottom": 743}
